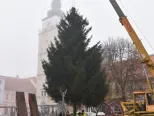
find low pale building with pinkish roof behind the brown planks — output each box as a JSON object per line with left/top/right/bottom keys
{"left": 0, "top": 75, "right": 36, "bottom": 116}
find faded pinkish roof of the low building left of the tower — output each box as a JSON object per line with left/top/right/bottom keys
{"left": 0, "top": 75, "right": 36, "bottom": 94}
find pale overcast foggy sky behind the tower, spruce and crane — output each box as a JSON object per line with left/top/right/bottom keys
{"left": 0, "top": 0, "right": 154, "bottom": 78}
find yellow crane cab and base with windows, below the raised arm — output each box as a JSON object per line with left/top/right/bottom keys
{"left": 121, "top": 91, "right": 154, "bottom": 116}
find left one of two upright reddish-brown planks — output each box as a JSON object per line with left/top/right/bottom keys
{"left": 16, "top": 92, "right": 28, "bottom": 116}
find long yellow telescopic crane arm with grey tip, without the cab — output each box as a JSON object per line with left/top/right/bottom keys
{"left": 110, "top": 0, "right": 154, "bottom": 91}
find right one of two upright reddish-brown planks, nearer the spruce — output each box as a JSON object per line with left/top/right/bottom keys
{"left": 28, "top": 94, "right": 39, "bottom": 116}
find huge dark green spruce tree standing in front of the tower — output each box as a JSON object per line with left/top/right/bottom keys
{"left": 43, "top": 7, "right": 108, "bottom": 115}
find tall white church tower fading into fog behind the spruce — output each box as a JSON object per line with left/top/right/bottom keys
{"left": 36, "top": 0, "right": 63, "bottom": 105}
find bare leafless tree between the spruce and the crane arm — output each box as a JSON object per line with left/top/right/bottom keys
{"left": 104, "top": 37, "right": 143, "bottom": 101}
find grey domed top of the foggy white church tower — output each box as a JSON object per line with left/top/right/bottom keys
{"left": 48, "top": 0, "right": 62, "bottom": 17}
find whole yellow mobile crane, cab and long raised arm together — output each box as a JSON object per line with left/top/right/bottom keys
{"left": 109, "top": 0, "right": 154, "bottom": 116}
